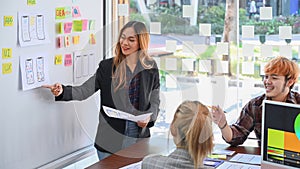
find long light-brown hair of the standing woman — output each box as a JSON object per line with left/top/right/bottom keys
{"left": 112, "top": 21, "right": 153, "bottom": 91}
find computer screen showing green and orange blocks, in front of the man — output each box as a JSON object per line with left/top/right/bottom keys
{"left": 261, "top": 100, "right": 300, "bottom": 169}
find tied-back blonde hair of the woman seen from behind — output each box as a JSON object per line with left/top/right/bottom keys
{"left": 171, "top": 101, "right": 213, "bottom": 169}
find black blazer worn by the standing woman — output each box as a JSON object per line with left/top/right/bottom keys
{"left": 55, "top": 58, "right": 160, "bottom": 153}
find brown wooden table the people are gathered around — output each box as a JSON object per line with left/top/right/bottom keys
{"left": 87, "top": 137, "right": 260, "bottom": 169}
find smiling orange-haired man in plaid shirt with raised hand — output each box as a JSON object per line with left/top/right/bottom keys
{"left": 212, "top": 56, "right": 300, "bottom": 146}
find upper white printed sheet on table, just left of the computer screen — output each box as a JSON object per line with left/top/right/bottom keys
{"left": 229, "top": 153, "right": 261, "bottom": 164}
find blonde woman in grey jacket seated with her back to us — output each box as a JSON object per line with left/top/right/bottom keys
{"left": 142, "top": 101, "right": 213, "bottom": 169}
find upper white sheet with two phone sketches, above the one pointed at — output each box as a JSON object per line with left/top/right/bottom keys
{"left": 18, "top": 12, "right": 50, "bottom": 47}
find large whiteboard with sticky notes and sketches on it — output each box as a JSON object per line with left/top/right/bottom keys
{"left": 0, "top": 0, "right": 103, "bottom": 169}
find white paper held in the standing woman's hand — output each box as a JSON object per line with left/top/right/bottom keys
{"left": 103, "top": 106, "right": 152, "bottom": 122}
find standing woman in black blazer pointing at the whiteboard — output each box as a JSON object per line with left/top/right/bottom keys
{"left": 44, "top": 21, "right": 160, "bottom": 160}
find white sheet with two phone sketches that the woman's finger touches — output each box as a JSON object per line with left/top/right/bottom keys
{"left": 20, "top": 56, "right": 50, "bottom": 90}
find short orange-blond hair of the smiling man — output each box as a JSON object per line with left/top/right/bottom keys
{"left": 264, "top": 56, "right": 299, "bottom": 88}
